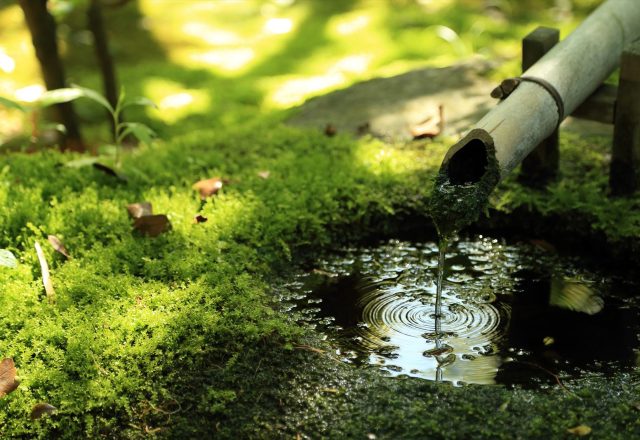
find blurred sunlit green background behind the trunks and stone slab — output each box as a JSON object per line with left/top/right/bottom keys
{"left": 0, "top": 0, "right": 601, "bottom": 144}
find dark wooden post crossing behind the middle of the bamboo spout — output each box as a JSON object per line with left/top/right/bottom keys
{"left": 518, "top": 26, "right": 560, "bottom": 187}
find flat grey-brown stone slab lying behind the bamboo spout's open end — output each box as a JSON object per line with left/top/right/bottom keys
{"left": 289, "top": 60, "right": 496, "bottom": 141}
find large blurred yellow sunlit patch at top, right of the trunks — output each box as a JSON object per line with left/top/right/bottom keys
{"left": 141, "top": 1, "right": 309, "bottom": 77}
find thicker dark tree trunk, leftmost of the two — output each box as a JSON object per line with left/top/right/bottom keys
{"left": 19, "top": 0, "right": 84, "bottom": 151}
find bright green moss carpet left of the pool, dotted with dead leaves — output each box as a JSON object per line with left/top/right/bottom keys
{"left": 0, "top": 123, "right": 440, "bottom": 438}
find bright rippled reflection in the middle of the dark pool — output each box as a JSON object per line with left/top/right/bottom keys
{"left": 344, "top": 276, "right": 510, "bottom": 383}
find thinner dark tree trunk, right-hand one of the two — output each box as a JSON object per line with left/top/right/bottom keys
{"left": 87, "top": 0, "right": 122, "bottom": 141}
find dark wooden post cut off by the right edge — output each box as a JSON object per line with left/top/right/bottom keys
{"left": 609, "top": 40, "right": 640, "bottom": 196}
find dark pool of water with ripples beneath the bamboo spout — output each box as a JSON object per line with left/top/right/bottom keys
{"left": 280, "top": 236, "right": 640, "bottom": 386}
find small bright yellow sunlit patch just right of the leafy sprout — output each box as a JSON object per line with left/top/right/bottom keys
{"left": 143, "top": 77, "right": 211, "bottom": 123}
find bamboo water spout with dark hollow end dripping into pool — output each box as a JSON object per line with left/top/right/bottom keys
{"left": 434, "top": 0, "right": 640, "bottom": 234}
